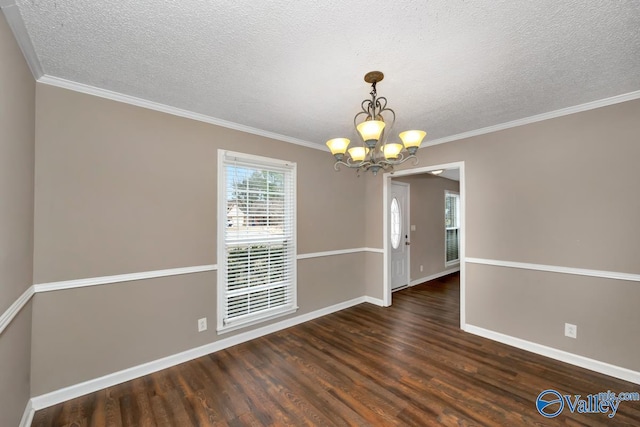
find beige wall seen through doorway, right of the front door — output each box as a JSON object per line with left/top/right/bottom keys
{"left": 394, "top": 173, "right": 460, "bottom": 281}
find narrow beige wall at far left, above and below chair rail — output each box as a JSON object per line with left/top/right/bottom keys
{"left": 0, "top": 14, "right": 35, "bottom": 426}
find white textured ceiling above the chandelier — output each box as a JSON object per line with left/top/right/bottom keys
{"left": 8, "top": 0, "right": 640, "bottom": 144}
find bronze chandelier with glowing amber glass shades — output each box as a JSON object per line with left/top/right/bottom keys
{"left": 327, "top": 71, "right": 427, "bottom": 175}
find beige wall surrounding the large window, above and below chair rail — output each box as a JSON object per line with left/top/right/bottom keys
{"left": 31, "top": 84, "right": 366, "bottom": 395}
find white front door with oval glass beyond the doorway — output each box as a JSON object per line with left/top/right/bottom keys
{"left": 386, "top": 181, "right": 410, "bottom": 290}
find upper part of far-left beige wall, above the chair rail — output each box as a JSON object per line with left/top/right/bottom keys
{"left": 0, "top": 15, "right": 35, "bottom": 312}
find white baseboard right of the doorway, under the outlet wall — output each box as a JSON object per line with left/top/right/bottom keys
{"left": 464, "top": 324, "right": 640, "bottom": 384}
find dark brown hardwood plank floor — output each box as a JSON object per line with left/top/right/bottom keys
{"left": 32, "top": 274, "right": 640, "bottom": 427}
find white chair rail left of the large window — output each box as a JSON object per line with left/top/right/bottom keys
{"left": 34, "top": 264, "right": 218, "bottom": 292}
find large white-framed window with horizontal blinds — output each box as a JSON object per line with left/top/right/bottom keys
{"left": 218, "top": 150, "right": 297, "bottom": 332}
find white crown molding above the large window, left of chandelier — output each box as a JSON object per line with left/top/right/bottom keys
{"left": 37, "top": 74, "right": 329, "bottom": 151}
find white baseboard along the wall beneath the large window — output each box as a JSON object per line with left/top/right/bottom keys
{"left": 30, "top": 297, "right": 367, "bottom": 410}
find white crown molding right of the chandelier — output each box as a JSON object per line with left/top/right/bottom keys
{"left": 421, "top": 90, "right": 640, "bottom": 148}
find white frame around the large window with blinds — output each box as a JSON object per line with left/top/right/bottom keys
{"left": 216, "top": 149, "right": 298, "bottom": 334}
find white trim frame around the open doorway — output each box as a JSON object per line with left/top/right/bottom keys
{"left": 382, "top": 161, "right": 466, "bottom": 330}
